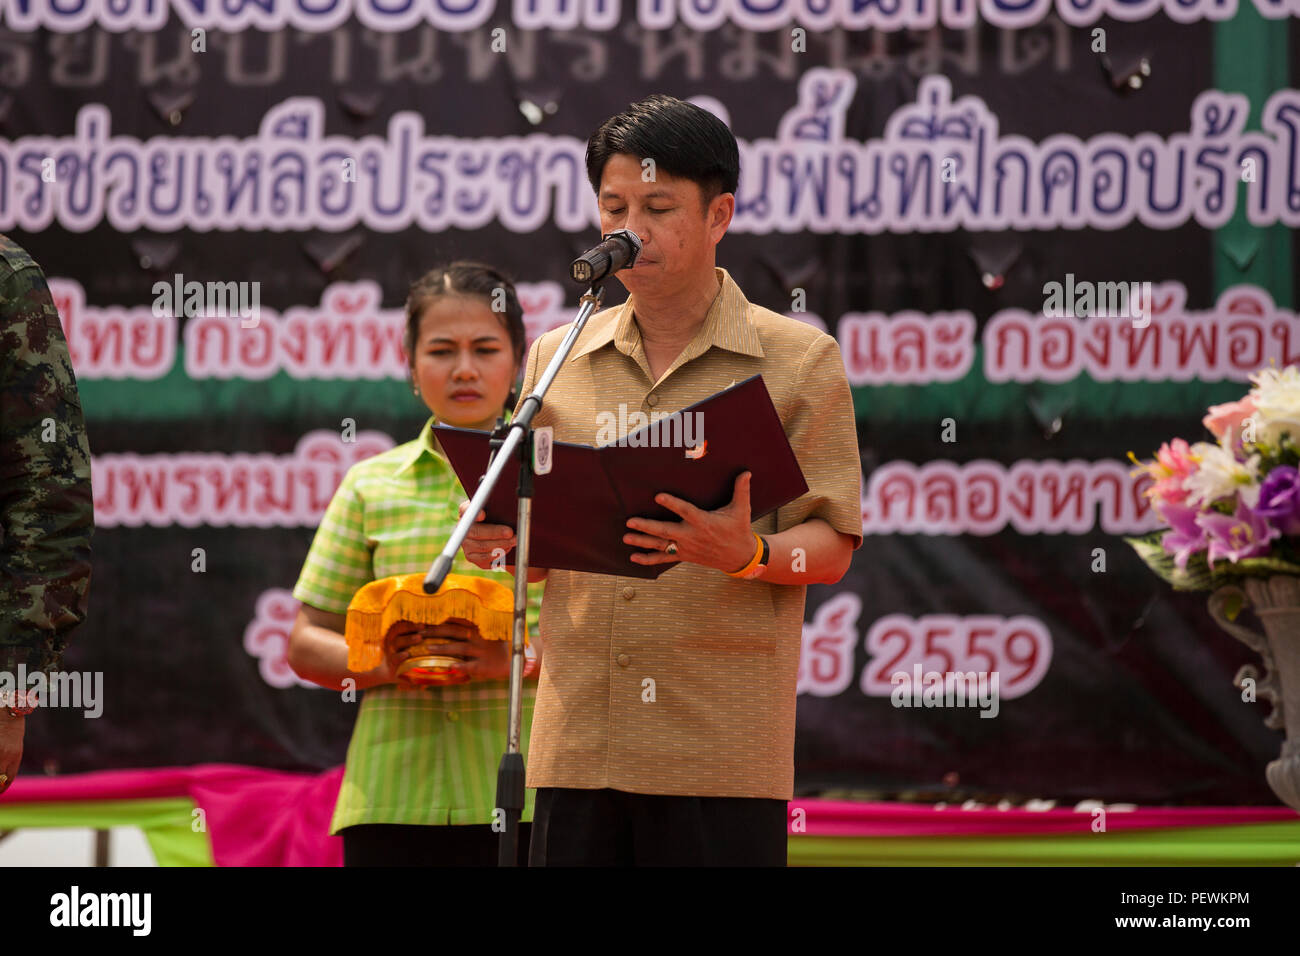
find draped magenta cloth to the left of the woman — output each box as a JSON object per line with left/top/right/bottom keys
{"left": 0, "top": 763, "right": 343, "bottom": 866}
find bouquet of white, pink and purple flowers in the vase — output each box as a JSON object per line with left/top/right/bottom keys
{"left": 1125, "top": 365, "right": 1300, "bottom": 591}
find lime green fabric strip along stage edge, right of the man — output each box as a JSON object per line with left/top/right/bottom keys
{"left": 789, "top": 819, "right": 1300, "bottom": 866}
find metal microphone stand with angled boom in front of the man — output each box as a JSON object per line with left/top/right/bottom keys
{"left": 424, "top": 277, "right": 611, "bottom": 866}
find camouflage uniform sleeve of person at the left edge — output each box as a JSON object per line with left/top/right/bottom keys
{"left": 0, "top": 235, "right": 94, "bottom": 674}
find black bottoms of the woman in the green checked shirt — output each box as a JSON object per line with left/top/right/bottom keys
{"left": 338, "top": 823, "right": 533, "bottom": 866}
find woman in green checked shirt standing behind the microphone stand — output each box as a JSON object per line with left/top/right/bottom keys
{"left": 289, "top": 261, "right": 542, "bottom": 866}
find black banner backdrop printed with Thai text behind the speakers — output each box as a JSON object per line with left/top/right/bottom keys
{"left": 0, "top": 5, "right": 1296, "bottom": 804}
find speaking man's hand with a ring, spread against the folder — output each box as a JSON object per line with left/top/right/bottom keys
{"left": 623, "top": 471, "right": 755, "bottom": 574}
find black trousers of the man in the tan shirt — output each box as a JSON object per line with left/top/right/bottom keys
{"left": 528, "top": 787, "right": 787, "bottom": 866}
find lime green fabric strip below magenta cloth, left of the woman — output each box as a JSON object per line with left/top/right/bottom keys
{"left": 0, "top": 797, "right": 216, "bottom": 866}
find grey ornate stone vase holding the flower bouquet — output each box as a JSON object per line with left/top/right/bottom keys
{"left": 1209, "top": 575, "right": 1300, "bottom": 810}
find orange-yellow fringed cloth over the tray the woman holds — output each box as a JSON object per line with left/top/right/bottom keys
{"left": 343, "top": 574, "right": 528, "bottom": 674}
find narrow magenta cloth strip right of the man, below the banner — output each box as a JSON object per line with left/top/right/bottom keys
{"left": 787, "top": 800, "right": 1296, "bottom": 836}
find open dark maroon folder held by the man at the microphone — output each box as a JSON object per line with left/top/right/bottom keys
{"left": 433, "top": 375, "right": 809, "bottom": 578}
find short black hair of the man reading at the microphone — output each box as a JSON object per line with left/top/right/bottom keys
{"left": 586, "top": 92, "right": 740, "bottom": 206}
